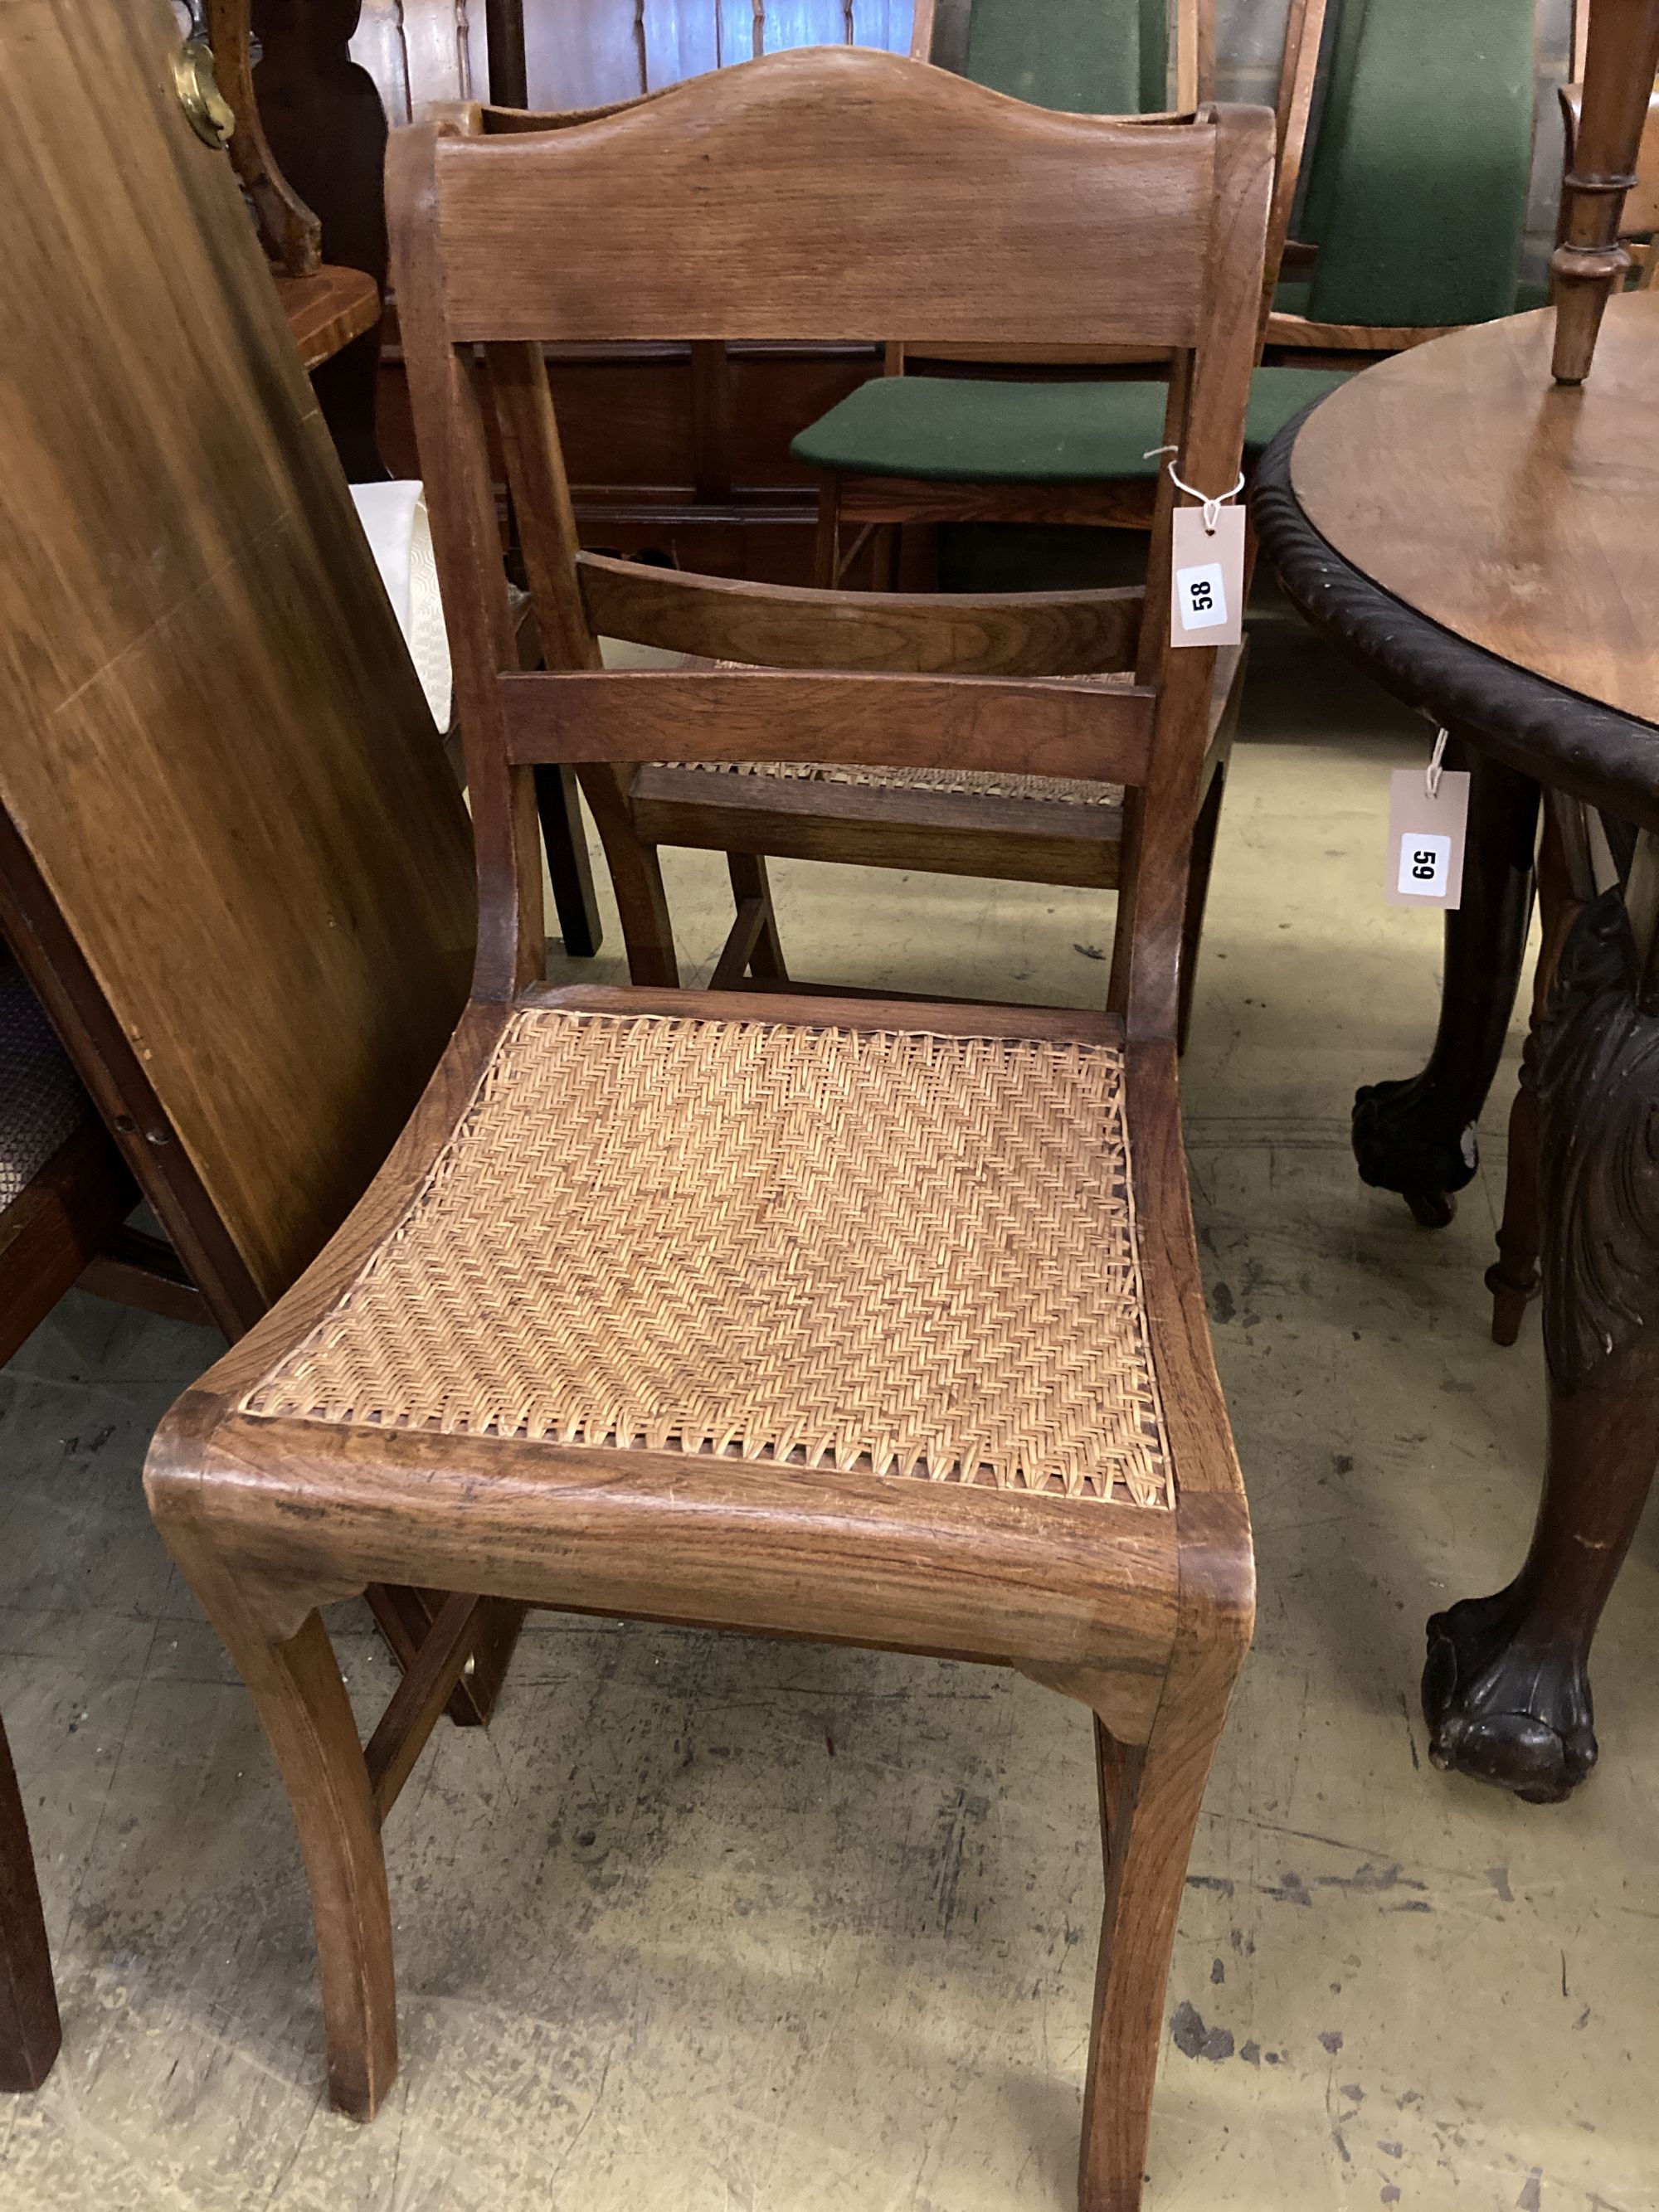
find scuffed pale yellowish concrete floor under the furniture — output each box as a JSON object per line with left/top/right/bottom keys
{"left": 0, "top": 597, "right": 1659, "bottom": 2212}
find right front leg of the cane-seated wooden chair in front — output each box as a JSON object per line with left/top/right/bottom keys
{"left": 1078, "top": 1692, "right": 1225, "bottom": 2212}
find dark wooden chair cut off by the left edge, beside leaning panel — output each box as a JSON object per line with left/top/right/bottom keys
{"left": 0, "top": 958, "right": 137, "bottom": 2090}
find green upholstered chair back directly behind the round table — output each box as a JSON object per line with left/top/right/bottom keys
{"left": 1297, "top": 0, "right": 1533, "bottom": 325}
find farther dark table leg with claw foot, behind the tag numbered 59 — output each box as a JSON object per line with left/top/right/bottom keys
{"left": 1354, "top": 739, "right": 1537, "bottom": 1228}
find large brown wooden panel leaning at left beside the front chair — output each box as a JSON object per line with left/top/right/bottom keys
{"left": 0, "top": 0, "right": 474, "bottom": 1296}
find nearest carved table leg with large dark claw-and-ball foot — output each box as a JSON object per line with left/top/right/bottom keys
{"left": 1423, "top": 889, "right": 1659, "bottom": 1805}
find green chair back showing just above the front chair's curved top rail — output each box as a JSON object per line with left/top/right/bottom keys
{"left": 965, "top": 0, "right": 1170, "bottom": 115}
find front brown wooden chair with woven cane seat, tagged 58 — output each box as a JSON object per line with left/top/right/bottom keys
{"left": 146, "top": 51, "right": 1272, "bottom": 2212}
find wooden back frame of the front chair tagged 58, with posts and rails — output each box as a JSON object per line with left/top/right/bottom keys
{"left": 387, "top": 49, "right": 1274, "bottom": 1035}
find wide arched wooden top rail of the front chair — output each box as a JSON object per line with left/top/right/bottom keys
{"left": 422, "top": 49, "right": 1214, "bottom": 348}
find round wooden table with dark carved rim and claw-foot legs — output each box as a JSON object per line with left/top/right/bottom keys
{"left": 1252, "top": 292, "right": 1659, "bottom": 1801}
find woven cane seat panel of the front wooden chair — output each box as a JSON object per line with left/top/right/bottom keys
{"left": 250, "top": 1006, "right": 1175, "bottom": 1509}
